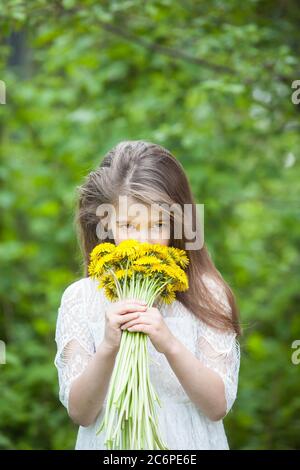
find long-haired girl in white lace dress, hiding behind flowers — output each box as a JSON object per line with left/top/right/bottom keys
{"left": 54, "top": 141, "right": 241, "bottom": 450}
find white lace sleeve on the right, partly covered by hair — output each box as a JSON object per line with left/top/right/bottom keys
{"left": 195, "top": 279, "right": 240, "bottom": 415}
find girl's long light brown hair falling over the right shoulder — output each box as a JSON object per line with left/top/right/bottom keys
{"left": 74, "top": 140, "right": 242, "bottom": 335}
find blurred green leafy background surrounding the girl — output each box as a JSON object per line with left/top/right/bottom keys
{"left": 0, "top": 0, "right": 300, "bottom": 449}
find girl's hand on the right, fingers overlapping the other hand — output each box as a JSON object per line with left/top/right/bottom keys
{"left": 121, "top": 307, "right": 174, "bottom": 354}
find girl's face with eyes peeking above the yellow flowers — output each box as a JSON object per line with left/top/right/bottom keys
{"left": 110, "top": 198, "right": 170, "bottom": 246}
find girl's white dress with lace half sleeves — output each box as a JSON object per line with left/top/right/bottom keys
{"left": 54, "top": 277, "right": 240, "bottom": 450}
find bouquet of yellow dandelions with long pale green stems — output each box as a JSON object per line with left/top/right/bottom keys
{"left": 89, "top": 240, "right": 189, "bottom": 450}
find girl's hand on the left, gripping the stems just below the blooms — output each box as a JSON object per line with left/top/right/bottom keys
{"left": 103, "top": 299, "right": 147, "bottom": 352}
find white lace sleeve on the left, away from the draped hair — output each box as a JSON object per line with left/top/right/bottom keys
{"left": 54, "top": 280, "right": 95, "bottom": 410}
